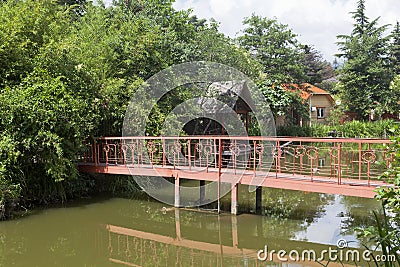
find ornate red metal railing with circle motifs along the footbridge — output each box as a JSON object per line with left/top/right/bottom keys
{"left": 81, "top": 136, "right": 393, "bottom": 185}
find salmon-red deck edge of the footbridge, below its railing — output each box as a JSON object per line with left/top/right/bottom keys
{"left": 79, "top": 164, "right": 387, "bottom": 198}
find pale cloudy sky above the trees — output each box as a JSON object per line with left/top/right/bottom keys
{"left": 174, "top": 0, "right": 400, "bottom": 62}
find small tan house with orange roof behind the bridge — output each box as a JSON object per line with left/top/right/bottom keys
{"left": 282, "top": 83, "right": 335, "bottom": 125}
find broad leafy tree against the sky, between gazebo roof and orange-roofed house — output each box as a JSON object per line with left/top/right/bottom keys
{"left": 237, "top": 14, "right": 305, "bottom": 83}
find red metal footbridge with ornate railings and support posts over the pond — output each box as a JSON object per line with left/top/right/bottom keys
{"left": 79, "top": 136, "right": 393, "bottom": 213}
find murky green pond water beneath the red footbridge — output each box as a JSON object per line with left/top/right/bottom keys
{"left": 0, "top": 187, "right": 377, "bottom": 266}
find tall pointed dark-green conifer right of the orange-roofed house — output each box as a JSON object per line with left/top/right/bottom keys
{"left": 337, "top": 0, "right": 391, "bottom": 119}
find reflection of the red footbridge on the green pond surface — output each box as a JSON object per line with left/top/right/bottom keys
{"left": 103, "top": 209, "right": 368, "bottom": 267}
